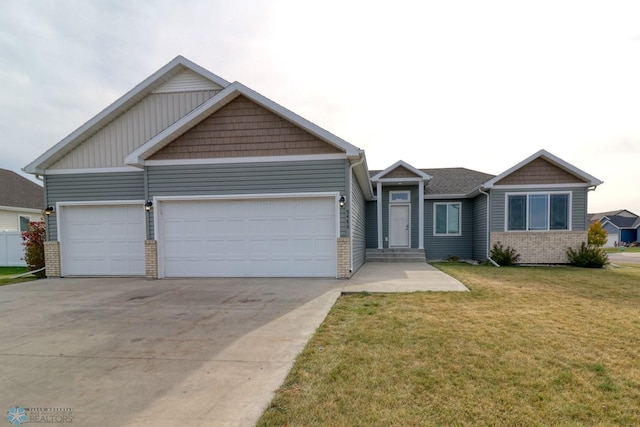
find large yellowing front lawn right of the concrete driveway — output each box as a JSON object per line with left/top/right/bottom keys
{"left": 258, "top": 263, "right": 640, "bottom": 426}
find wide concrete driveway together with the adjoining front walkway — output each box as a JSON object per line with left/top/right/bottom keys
{"left": 0, "top": 264, "right": 466, "bottom": 426}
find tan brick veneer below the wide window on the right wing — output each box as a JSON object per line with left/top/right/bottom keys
{"left": 491, "top": 231, "right": 587, "bottom": 264}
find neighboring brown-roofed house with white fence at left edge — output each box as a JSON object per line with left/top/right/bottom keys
{"left": 0, "top": 169, "right": 44, "bottom": 266}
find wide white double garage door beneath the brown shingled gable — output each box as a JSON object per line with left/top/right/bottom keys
{"left": 156, "top": 197, "right": 337, "bottom": 277}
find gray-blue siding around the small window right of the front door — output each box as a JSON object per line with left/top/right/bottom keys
{"left": 424, "top": 199, "right": 474, "bottom": 260}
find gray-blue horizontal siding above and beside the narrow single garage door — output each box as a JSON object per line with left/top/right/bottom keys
{"left": 44, "top": 171, "right": 145, "bottom": 240}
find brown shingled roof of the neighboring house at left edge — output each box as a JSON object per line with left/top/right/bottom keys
{"left": 0, "top": 169, "right": 44, "bottom": 210}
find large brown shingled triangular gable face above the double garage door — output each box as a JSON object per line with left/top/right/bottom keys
{"left": 148, "top": 96, "right": 342, "bottom": 160}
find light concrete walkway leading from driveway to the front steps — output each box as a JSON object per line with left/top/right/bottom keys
{"left": 342, "top": 262, "right": 469, "bottom": 293}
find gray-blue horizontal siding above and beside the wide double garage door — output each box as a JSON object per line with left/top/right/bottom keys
{"left": 146, "top": 159, "right": 349, "bottom": 237}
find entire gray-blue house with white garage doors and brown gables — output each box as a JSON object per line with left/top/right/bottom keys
{"left": 24, "top": 56, "right": 601, "bottom": 278}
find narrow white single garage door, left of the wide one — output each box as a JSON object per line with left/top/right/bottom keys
{"left": 58, "top": 204, "right": 146, "bottom": 276}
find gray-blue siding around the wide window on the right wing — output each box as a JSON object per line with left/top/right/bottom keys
{"left": 491, "top": 187, "right": 589, "bottom": 231}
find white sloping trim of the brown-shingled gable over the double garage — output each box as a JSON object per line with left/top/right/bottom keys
{"left": 125, "top": 82, "right": 363, "bottom": 167}
